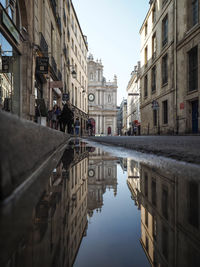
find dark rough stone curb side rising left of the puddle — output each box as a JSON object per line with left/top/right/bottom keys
{"left": 0, "top": 111, "right": 69, "bottom": 200}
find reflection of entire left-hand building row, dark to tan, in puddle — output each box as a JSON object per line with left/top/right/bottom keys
{"left": 5, "top": 141, "right": 88, "bottom": 267}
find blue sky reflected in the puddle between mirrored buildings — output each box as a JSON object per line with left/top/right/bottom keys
{"left": 74, "top": 165, "right": 149, "bottom": 267}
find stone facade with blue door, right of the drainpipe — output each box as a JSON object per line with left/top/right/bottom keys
{"left": 177, "top": 0, "right": 200, "bottom": 133}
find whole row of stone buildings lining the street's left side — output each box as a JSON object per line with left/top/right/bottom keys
{"left": 0, "top": 0, "right": 88, "bottom": 132}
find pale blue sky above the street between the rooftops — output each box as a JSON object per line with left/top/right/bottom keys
{"left": 73, "top": 0, "right": 149, "bottom": 105}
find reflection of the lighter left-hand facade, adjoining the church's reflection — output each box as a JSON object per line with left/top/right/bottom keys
{"left": 64, "top": 143, "right": 88, "bottom": 266}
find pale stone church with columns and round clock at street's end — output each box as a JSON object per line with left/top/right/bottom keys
{"left": 88, "top": 54, "right": 117, "bottom": 135}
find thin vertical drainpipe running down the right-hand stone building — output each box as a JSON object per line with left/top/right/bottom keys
{"left": 174, "top": 0, "right": 179, "bottom": 134}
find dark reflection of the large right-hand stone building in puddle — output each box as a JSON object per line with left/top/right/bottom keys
{"left": 138, "top": 164, "right": 200, "bottom": 267}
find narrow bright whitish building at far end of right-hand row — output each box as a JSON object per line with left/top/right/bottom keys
{"left": 126, "top": 63, "right": 141, "bottom": 135}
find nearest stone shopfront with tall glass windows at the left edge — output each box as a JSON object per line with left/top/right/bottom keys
{"left": 0, "top": 0, "right": 34, "bottom": 118}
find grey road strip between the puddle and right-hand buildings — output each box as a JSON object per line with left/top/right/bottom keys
{"left": 89, "top": 136, "right": 200, "bottom": 164}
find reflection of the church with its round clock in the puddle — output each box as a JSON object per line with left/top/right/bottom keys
{"left": 88, "top": 148, "right": 117, "bottom": 216}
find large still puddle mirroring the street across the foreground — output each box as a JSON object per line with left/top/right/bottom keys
{"left": 0, "top": 139, "right": 200, "bottom": 267}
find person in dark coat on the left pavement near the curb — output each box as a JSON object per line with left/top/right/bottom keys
{"left": 60, "top": 103, "right": 74, "bottom": 134}
